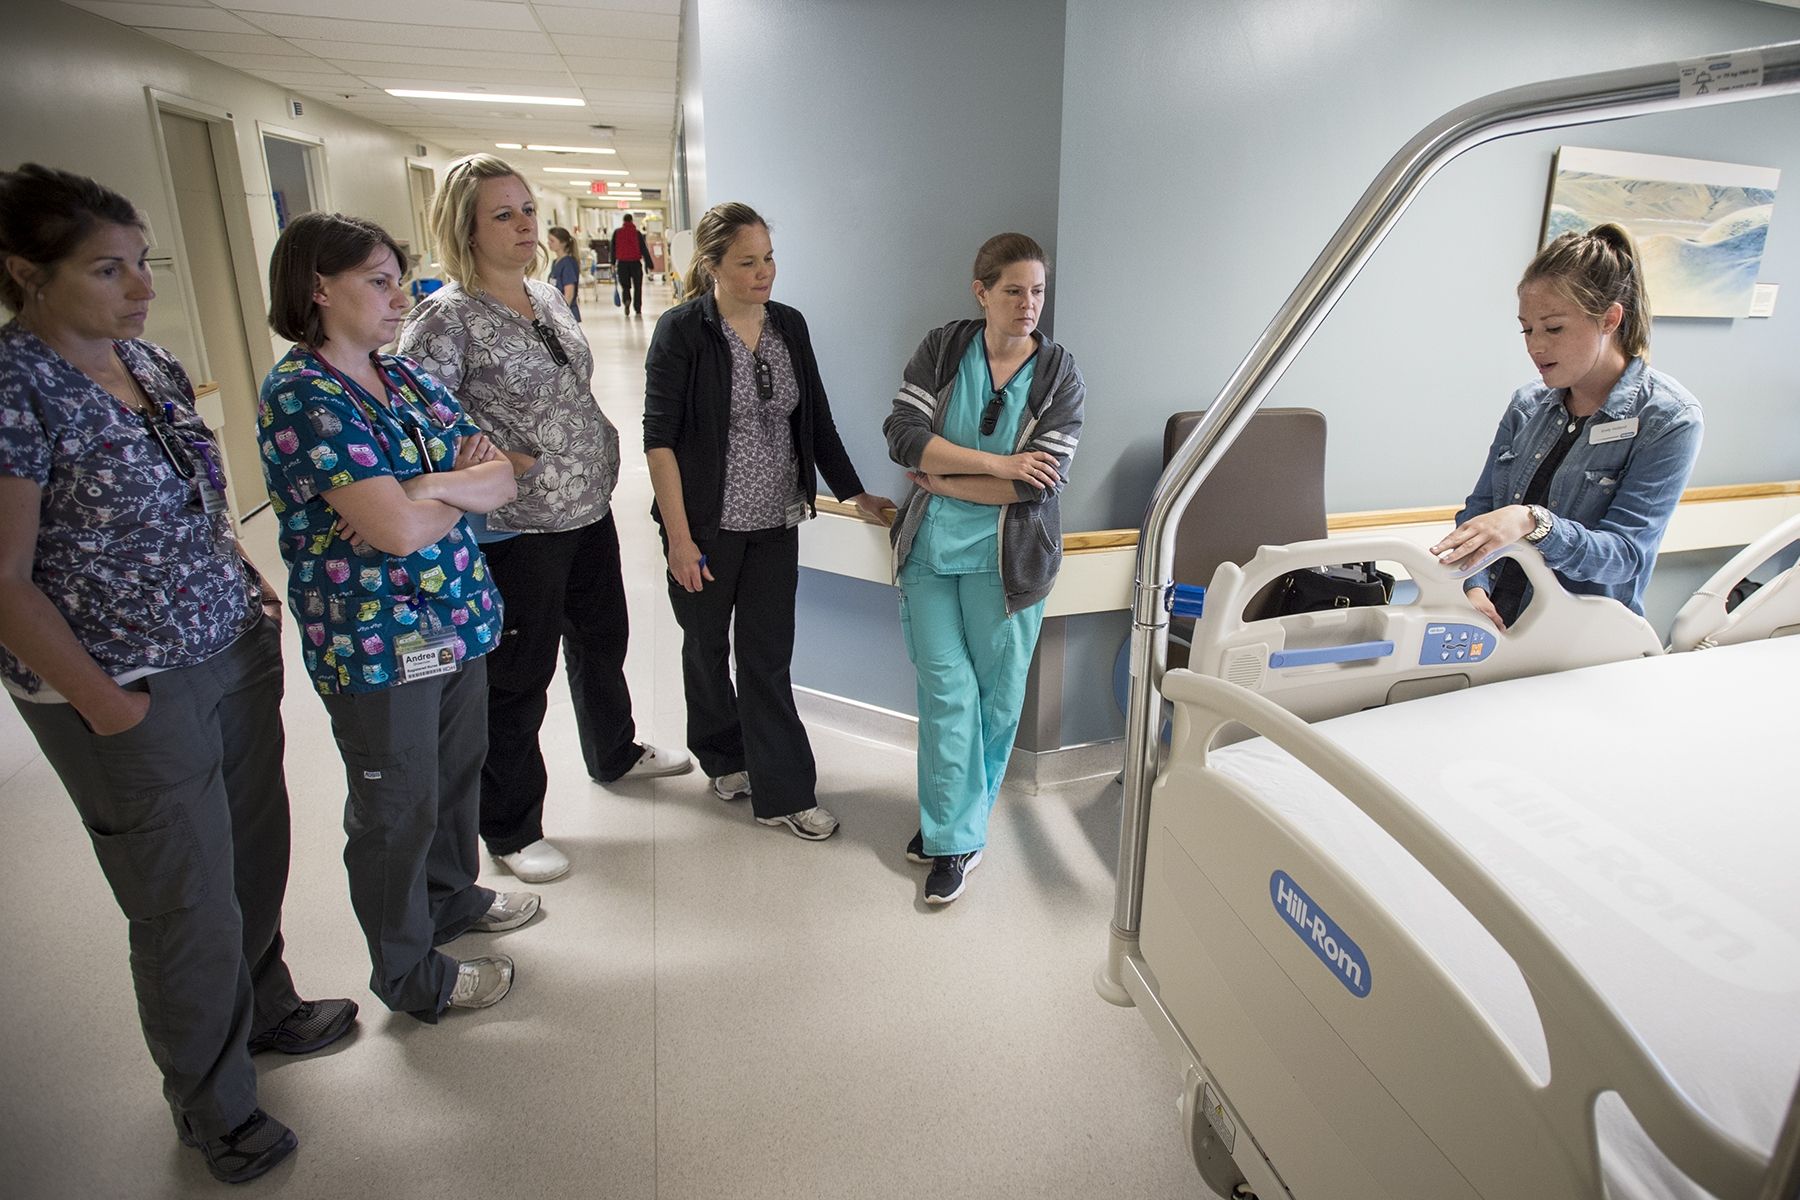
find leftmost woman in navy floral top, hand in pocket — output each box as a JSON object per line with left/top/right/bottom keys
{"left": 0, "top": 164, "right": 356, "bottom": 1184}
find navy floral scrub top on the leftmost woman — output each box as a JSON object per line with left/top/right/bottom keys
{"left": 0, "top": 320, "right": 257, "bottom": 702}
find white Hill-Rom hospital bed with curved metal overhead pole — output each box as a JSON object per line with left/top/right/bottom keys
{"left": 1094, "top": 43, "right": 1800, "bottom": 1200}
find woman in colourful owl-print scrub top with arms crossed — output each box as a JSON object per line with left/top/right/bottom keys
{"left": 257, "top": 212, "right": 538, "bottom": 1022}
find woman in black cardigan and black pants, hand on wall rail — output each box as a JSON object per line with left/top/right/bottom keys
{"left": 644, "top": 203, "right": 893, "bottom": 840}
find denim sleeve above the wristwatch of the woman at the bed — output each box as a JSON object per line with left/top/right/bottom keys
{"left": 1537, "top": 407, "right": 1701, "bottom": 585}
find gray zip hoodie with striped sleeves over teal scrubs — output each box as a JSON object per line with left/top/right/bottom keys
{"left": 882, "top": 320, "right": 1087, "bottom": 615}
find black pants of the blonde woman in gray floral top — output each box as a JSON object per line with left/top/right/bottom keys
{"left": 481, "top": 513, "right": 643, "bottom": 855}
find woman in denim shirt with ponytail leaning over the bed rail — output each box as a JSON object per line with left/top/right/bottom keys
{"left": 1431, "top": 225, "right": 1701, "bottom": 630}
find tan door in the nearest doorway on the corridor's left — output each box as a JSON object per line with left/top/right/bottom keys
{"left": 158, "top": 110, "right": 268, "bottom": 520}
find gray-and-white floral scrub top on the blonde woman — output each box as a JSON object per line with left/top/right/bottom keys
{"left": 400, "top": 279, "right": 619, "bottom": 533}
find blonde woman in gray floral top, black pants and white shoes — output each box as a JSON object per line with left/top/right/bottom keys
{"left": 400, "top": 155, "right": 693, "bottom": 883}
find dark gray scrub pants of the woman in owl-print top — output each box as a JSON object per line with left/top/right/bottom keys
{"left": 322, "top": 658, "right": 493, "bottom": 1022}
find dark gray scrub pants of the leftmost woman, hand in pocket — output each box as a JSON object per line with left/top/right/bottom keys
{"left": 18, "top": 617, "right": 301, "bottom": 1141}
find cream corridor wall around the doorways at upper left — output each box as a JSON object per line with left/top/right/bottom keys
{"left": 0, "top": 0, "right": 464, "bottom": 367}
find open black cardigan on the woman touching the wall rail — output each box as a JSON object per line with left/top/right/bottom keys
{"left": 644, "top": 293, "right": 864, "bottom": 538}
